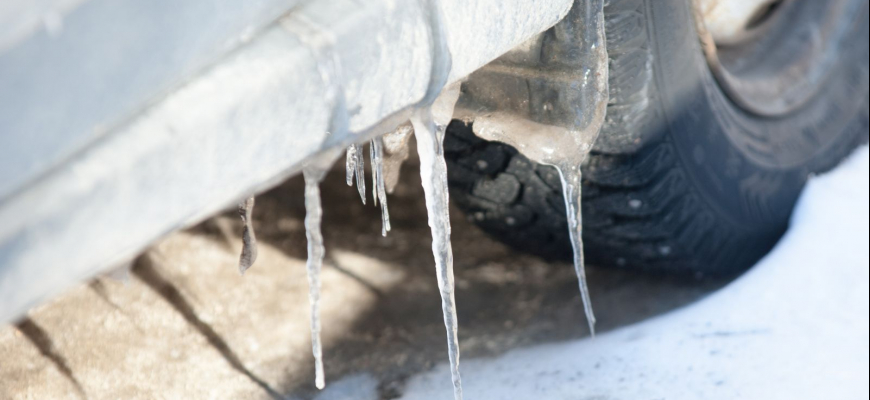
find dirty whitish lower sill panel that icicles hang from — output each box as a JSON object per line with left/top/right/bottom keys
{"left": 0, "top": 0, "right": 572, "bottom": 321}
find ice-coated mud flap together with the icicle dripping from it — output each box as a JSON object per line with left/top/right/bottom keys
{"left": 457, "top": 0, "right": 609, "bottom": 335}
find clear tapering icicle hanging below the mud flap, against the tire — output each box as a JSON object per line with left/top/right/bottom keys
{"left": 556, "top": 166, "right": 595, "bottom": 337}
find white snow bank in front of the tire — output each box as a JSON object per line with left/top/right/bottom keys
{"left": 316, "top": 148, "right": 870, "bottom": 400}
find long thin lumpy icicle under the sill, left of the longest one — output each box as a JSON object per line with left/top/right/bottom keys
{"left": 302, "top": 168, "right": 326, "bottom": 389}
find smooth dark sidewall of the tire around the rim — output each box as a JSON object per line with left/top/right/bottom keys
{"left": 646, "top": 0, "right": 868, "bottom": 232}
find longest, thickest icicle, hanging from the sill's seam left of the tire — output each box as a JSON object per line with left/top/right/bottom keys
{"left": 411, "top": 81, "right": 462, "bottom": 400}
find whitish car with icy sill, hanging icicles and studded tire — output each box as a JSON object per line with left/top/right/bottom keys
{"left": 0, "top": 0, "right": 870, "bottom": 396}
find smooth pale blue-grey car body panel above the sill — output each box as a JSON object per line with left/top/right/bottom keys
{"left": 0, "top": 0, "right": 310, "bottom": 199}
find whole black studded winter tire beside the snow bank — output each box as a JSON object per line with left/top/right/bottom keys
{"left": 445, "top": 0, "right": 868, "bottom": 276}
